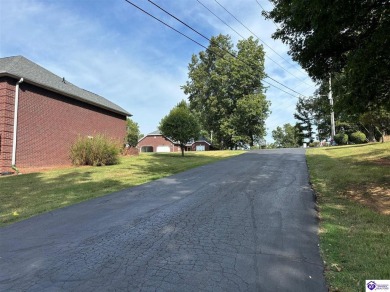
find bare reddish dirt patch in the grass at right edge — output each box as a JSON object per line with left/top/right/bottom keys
{"left": 347, "top": 185, "right": 390, "bottom": 215}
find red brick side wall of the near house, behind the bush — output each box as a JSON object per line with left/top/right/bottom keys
{"left": 0, "top": 80, "right": 126, "bottom": 170}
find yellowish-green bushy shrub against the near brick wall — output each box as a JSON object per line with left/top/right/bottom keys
{"left": 70, "top": 135, "right": 120, "bottom": 166}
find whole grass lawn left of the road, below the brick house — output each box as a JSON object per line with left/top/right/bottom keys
{"left": 0, "top": 151, "right": 243, "bottom": 226}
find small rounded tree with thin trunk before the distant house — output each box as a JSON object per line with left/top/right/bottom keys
{"left": 159, "top": 100, "right": 200, "bottom": 156}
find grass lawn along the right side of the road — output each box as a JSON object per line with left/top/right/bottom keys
{"left": 307, "top": 143, "right": 390, "bottom": 291}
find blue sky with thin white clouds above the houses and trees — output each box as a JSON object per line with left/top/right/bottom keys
{"left": 0, "top": 0, "right": 315, "bottom": 142}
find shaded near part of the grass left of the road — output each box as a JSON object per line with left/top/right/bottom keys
{"left": 0, "top": 172, "right": 129, "bottom": 226}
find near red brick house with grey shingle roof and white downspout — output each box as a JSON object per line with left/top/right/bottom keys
{"left": 0, "top": 56, "right": 131, "bottom": 172}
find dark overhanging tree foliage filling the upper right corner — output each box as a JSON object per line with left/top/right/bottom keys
{"left": 263, "top": 0, "right": 390, "bottom": 113}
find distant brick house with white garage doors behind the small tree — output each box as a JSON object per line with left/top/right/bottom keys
{"left": 137, "top": 130, "right": 211, "bottom": 152}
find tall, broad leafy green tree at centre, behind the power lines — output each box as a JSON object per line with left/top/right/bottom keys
{"left": 182, "top": 35, "right": 269, "bottom": 148}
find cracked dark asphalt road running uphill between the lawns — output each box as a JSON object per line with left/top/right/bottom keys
{"left": 0, "top": 149, "right": 327, "bottom": 292}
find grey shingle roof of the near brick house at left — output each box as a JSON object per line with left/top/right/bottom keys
{"left": 0, "top": 56, "right": 131, "bottom": 116}
